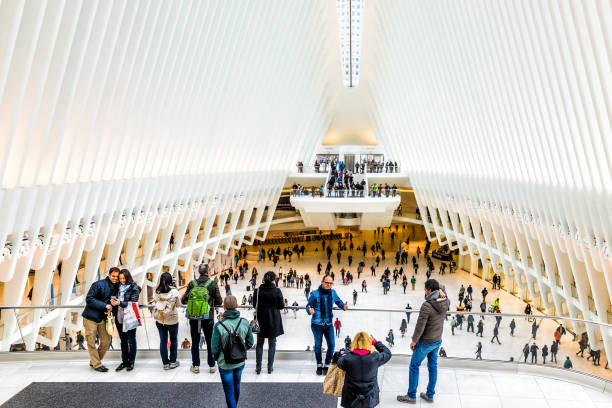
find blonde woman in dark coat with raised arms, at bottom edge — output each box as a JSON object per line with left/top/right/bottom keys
{"left": 338, "top": 332, "right": 391, "bottom": 408}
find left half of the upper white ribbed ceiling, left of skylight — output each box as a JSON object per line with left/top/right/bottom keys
{"left": 0, "top": 0, "right": 341, "bottom": 189}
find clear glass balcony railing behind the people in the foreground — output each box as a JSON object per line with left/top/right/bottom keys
{"left": 0, "top": 301, "right": 612, "bottom": 379}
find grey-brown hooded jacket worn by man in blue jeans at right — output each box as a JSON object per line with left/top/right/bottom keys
{"left": 412, "top": 289, "right": 450, "bottom": 343}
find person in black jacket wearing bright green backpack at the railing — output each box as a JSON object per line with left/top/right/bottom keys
{"left": 181, "top": 264, "right": 223, "bottom": 374}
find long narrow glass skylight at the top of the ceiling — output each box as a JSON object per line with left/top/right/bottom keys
{"left": 336, "top": 0, "right": 364, "bottom": 87}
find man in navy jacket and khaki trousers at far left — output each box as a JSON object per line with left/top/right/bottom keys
{"left": 82, "top": 267, "right": 119, "bottom": 373}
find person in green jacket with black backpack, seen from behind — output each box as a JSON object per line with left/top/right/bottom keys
{"left": 212, "top": 295, "right": 253, "bottom": 408}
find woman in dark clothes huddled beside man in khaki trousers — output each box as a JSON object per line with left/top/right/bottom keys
{"left": 113, "top": 269, "right": 140, "bottom": 371}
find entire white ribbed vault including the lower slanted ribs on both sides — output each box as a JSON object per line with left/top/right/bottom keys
{"left": 0, "top": 0, "right": 612, "bottom": 354}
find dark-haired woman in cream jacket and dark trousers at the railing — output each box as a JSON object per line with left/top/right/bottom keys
{"left": 153, "top": 272, "right": 179, "bottom": 370}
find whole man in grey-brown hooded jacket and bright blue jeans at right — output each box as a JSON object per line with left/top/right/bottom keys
{"left": 397, "top": 279, "right": 450, "bottom": 404}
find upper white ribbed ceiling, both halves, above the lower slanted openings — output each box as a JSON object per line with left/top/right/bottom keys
{"left": 0, "top": 0, "right": 612, "bottom": 230}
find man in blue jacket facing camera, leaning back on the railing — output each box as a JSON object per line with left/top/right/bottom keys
{"left": 306, "top": 275, "right": 348, "bottom": 375}
